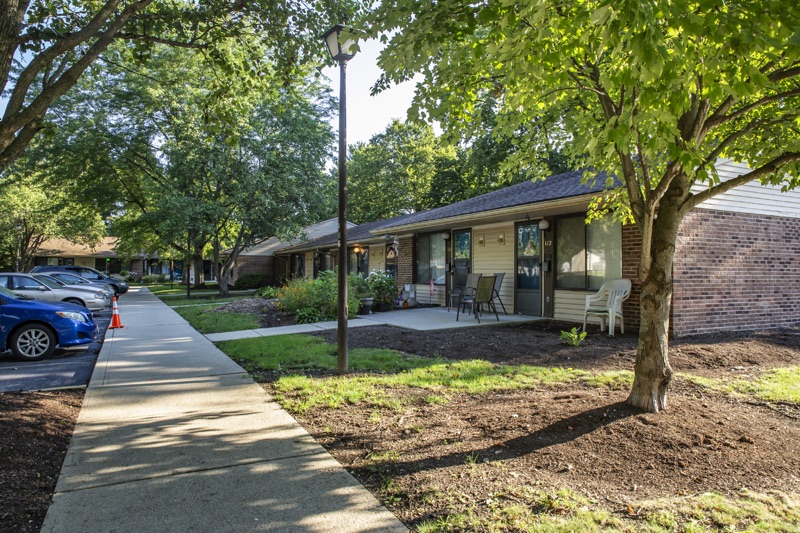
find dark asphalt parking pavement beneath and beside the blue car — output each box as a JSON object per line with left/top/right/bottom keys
{"left": 0, "top": 311, "right": 111, "bottom": 392}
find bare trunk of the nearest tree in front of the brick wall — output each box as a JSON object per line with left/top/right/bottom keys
{"left": 628, "top": 172, "right": 689, "bottom": 413}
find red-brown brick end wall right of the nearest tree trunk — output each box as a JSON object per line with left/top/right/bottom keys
{"left": 672, "top": 209, "right": 800, "bottom": 336}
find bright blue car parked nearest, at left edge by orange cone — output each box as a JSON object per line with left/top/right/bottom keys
{"left": 0, "top": 287, "right": 97, "bottom": 361}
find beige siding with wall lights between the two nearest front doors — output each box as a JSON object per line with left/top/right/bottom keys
{"left": 472, "top": 222, "right": 514, "bottom": 313}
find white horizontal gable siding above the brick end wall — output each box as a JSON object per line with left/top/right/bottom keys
{"left": 692, "top": 160, "right": 800, "bottom": 218}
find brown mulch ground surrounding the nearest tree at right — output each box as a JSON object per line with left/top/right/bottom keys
{"left": 298, "top": 322, "right": 800, "bottom": 526}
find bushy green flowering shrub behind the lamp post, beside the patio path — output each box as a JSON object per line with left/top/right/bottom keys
{"left": 278, "top": 271, "right": 361, "bottom": 320}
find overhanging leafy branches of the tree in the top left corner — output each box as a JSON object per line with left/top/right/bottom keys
{"left": 0, "top": 0, "right": 354, "bottom": 172}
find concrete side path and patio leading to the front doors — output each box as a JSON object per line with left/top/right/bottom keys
{"left": 206, "top": 307, "right": 541, "bottom": 342}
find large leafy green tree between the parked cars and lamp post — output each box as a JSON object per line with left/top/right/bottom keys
{"left": 41, "top": 43, "right": 333, "bottom": 293}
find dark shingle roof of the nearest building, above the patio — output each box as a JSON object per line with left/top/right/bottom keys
{"left": 376, "top": 170, "right": 606, "bottom": 228}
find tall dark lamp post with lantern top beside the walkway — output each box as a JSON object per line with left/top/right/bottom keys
{"left": 322, "top": 24, "right": 358, "bottom": 374}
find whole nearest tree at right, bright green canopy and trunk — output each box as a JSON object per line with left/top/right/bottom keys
{"left": 372, "top": 0, "right": 800, "bottom": 412}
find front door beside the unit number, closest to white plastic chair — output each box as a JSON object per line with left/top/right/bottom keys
{"left": 514, "top": 222, "right": 542, "bottom": 316}
